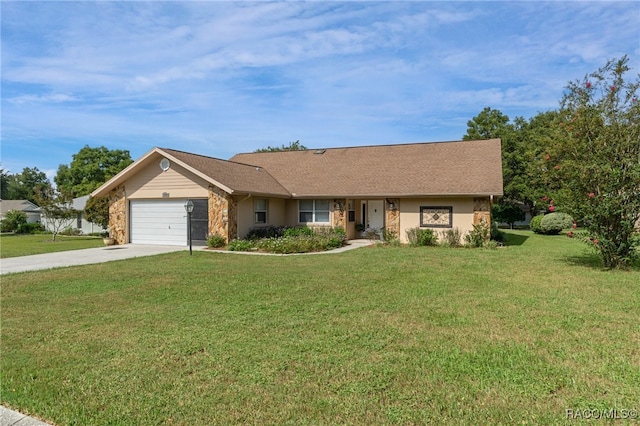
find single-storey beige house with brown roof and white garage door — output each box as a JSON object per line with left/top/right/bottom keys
{"left": 92, "top": 139, "right": 502, "bottom": 245}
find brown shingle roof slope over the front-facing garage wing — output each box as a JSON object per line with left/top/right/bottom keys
{"left": 160, "top": 148, "right": 290, "bottom": 197}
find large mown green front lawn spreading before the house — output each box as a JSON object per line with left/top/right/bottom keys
{"left": 0, "top": 231, "right": 640, "bottom": 425}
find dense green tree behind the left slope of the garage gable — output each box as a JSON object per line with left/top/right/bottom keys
{"left": 53, "top": 145, "right": 133, "bottom": 197}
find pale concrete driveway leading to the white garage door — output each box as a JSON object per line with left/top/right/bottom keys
{"left": 0, "top": 244, "right": 195, "bottom": 275}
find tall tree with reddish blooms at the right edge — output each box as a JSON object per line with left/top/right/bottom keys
{"left": 544, "top": 56, "right": 640, "bottom": 268}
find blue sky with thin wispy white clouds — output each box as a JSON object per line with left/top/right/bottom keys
{"left": 0, "top": 1, "right": 640, "bottom": 183}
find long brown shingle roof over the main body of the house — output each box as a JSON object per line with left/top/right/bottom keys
{"left": 231, "top": 139, "right": 502, "bottom": 197}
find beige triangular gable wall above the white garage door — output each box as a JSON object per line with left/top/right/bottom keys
{"left": 126, "top": 156, "right": 209, "bottom": 200}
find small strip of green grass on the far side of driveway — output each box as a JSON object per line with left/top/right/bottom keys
{"left": 0, "top": 234, "right": 104, "bottom": 259}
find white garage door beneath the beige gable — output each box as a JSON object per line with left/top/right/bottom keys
{"left": 130, "top": 200, "right": 188, "bottom": 246}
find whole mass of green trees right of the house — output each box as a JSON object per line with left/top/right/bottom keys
{"left": 463, "top": 56, "right": 640, "bottom": 268}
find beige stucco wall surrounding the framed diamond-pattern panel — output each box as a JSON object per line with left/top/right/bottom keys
{"left": 399, "top": 198, "right": 474, "bottom": 243}
